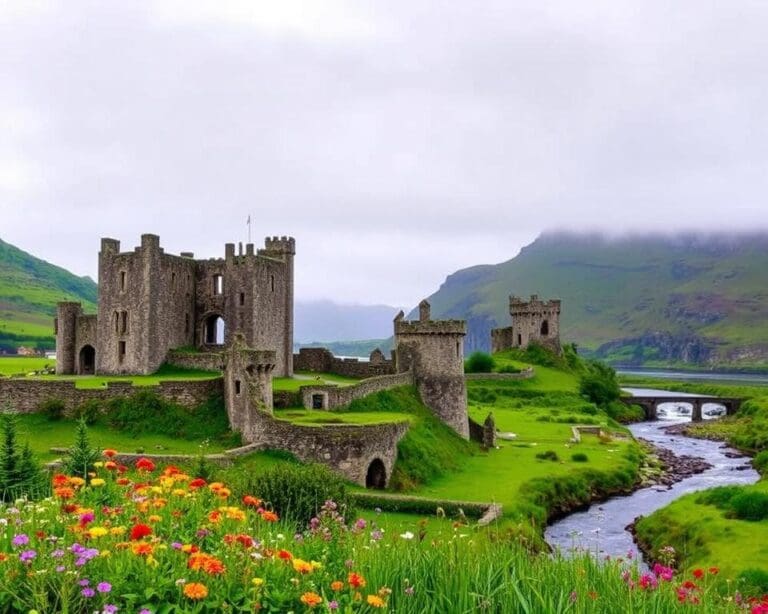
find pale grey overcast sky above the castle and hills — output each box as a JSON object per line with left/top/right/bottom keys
{"left": 0, "top": 0, "right": 768, "bottom": 305}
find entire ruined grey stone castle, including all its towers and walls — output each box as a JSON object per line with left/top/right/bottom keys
{"left": 48, "top": 234, "right": 560, "bottom": 487}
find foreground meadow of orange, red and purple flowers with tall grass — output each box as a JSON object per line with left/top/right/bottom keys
{"left": 0, "top": 450, "right": 768, "bottom": 614}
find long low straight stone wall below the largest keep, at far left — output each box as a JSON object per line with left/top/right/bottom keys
{"left": 0, "top": 378, "right": 223, "bottom": 414}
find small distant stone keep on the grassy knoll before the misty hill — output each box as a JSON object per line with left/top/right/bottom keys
{"left": 491, "top": 294, "right": 561, "bottom": 353}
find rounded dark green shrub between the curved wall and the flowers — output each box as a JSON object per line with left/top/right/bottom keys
{"left": 249, "top": 464, "right": 354, "bottom": 527}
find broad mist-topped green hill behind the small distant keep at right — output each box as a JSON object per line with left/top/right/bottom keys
{"left": 416, "top": 233, "right": 768, "bottom": 366}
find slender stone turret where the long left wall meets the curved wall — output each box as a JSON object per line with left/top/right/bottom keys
{"left": 224, "top": 334, "right": 276, "bottom": 441}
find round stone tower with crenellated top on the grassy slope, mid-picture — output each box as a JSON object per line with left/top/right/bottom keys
{"left": 394, "top": 301, "right": 469, "bottom": 439}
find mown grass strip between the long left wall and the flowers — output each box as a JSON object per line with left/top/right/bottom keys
{"left": 18, "top": 414, "right": 223, "bottom": 461}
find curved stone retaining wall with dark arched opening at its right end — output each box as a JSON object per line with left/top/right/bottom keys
{"left": 245, "top": 412, "right": 409, "bottom": 486}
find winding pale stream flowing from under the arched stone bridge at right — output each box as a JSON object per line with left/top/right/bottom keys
{"left": 545, "top": 389, "right": 759, "bottom": 558}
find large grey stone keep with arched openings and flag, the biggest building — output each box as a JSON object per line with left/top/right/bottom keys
{"left": 55, "top": 234, "right": 296, "bottom": 376}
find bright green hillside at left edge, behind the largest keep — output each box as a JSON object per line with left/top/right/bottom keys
{"left": 0, "top": 240, "right": 96, "bottom": 352}
